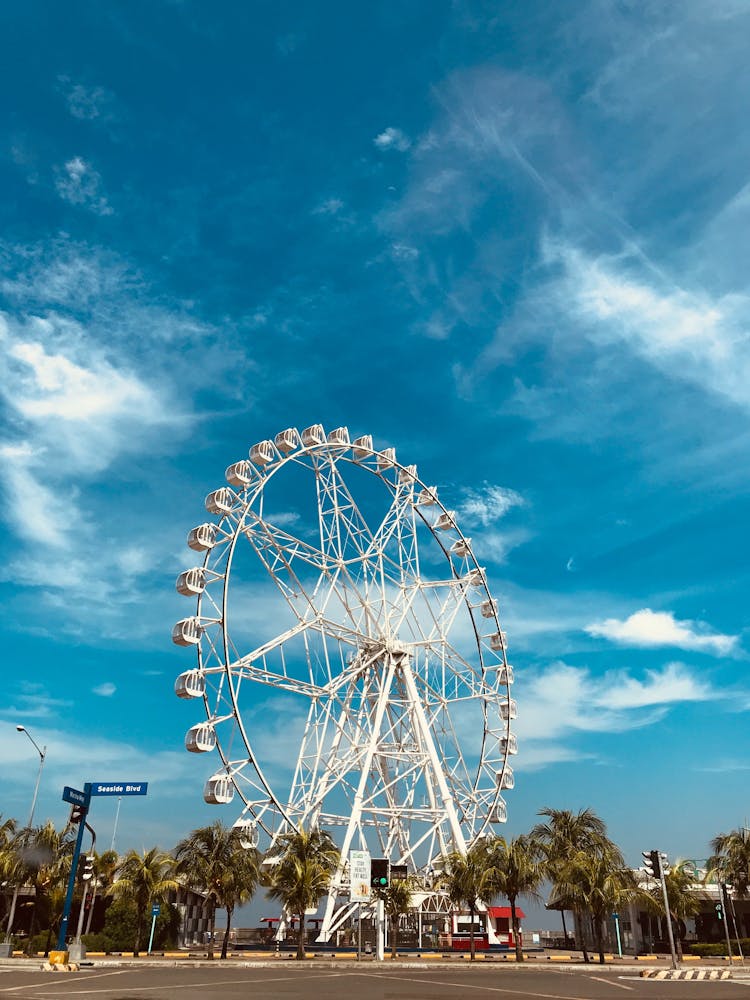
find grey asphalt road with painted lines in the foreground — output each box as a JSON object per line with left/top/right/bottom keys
{"left": 0, "top": 963, "right": 750, "bottom": 1000}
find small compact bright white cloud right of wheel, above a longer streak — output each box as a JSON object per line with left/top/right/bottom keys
{"left": 585, "top": 608, "right": 739, "bottom": 656}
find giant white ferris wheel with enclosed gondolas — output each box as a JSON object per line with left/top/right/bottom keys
{"left": 172, "top": 424, "right": 517, "bottom": 939}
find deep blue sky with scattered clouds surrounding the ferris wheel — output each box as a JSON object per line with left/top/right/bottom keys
{"left": 0, "top": 0, "right": 750, "bottom": 916}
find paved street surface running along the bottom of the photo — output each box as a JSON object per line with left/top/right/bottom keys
{"left": 0, "top": 957, "right": 750, "bottom": 1000}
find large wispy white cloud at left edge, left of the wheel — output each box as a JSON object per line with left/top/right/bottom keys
{"left": 0, "top": 240, "right": 237, "bottom": 641}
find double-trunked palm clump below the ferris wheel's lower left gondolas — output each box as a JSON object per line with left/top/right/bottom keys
{"left": 175, "top": 820, "right": 258, "bottom": 959}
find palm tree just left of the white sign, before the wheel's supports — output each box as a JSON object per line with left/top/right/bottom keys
{"left": 263, "top": 827, "right": 339, "bottom": 960}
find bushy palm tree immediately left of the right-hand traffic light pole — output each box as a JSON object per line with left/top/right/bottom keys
{"left": 555, "top": 843, "right": 638, "bottom": 965}
